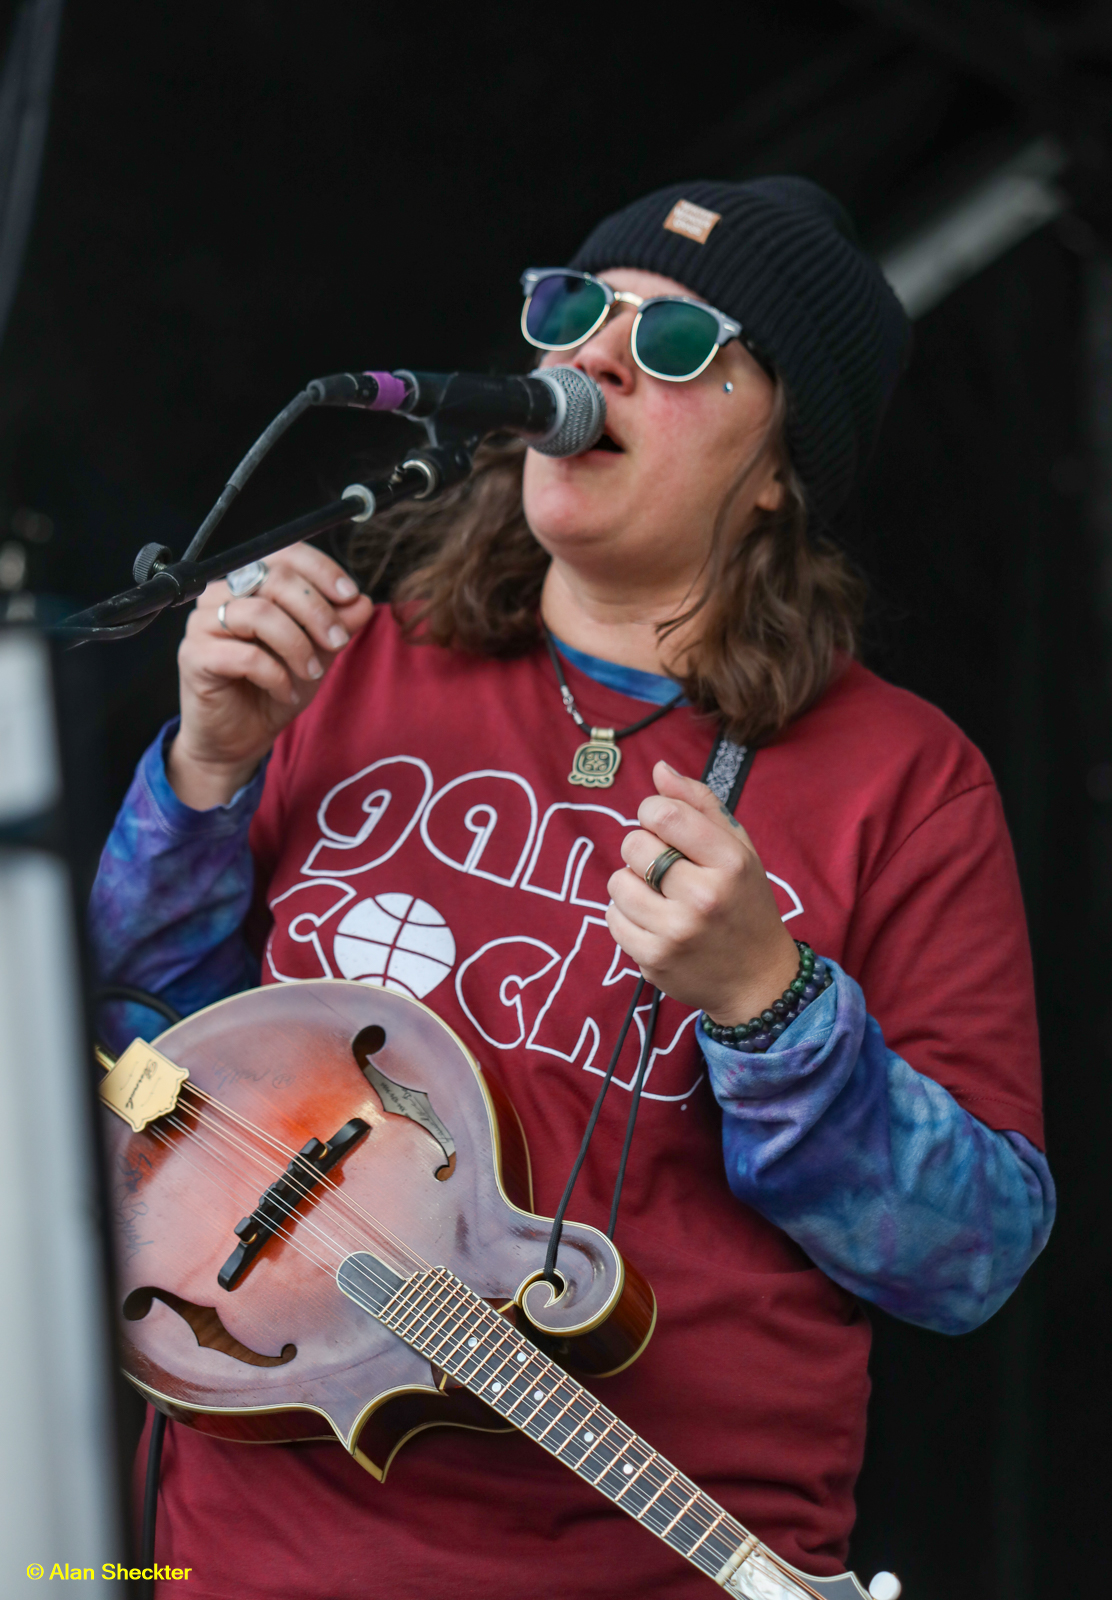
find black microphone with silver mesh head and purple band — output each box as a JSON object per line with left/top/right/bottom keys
{"left": 306, "top": 366, "right": 606, "bottom": 456}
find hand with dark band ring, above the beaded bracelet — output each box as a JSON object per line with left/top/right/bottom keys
{"left": 606, "top": 762, "right": 798, "bottom": 1026}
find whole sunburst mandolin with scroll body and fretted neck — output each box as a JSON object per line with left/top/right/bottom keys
{"left": 98, "top": 979, "right": 899, "bottom": 1600}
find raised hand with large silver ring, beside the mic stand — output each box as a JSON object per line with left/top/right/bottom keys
{"left": 166, "top": 544, "right": 373, "bottom": 810}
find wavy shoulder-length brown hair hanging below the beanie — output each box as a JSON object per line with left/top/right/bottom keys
{"left": 350, "top": 382, "right": 864, "bottom": 744}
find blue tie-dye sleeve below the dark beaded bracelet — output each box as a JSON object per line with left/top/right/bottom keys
{"left": 699, "top": 962, "right": 1054, "bottom": 1333}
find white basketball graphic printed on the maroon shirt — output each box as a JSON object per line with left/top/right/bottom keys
{"left": 333, "top": 894, "right": 456, "bottom": 1000}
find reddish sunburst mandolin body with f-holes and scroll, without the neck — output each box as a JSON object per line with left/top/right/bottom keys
{"left": 104, "top": 979, "right": 656, "bottom": 1477}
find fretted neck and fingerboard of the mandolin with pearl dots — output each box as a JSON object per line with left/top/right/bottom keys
{"left": 338, "top": 1253, "right": 864, "bottom": 1600}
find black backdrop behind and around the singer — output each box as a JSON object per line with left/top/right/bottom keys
{"left": 0, "top": 0, "right": 1112, "bottom": 1600}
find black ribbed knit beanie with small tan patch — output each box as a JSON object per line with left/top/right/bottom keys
{"left": 568, "top": 178, "right": 910, "bottom": 522}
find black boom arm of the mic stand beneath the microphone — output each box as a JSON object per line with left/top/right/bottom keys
{"left": 51, "top": 438, "right": 477, "bottom": 648}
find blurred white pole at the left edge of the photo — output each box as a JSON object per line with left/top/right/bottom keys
{"left": 0, "top": 629, "right": 126, "bottom": 1595}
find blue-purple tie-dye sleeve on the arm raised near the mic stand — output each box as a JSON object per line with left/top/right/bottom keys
{"left": 90, "top": 720, "right": 266, "bottom": 1048}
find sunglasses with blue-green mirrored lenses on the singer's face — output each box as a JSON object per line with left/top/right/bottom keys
{"left": 522, "top": 267, "right": 774, "bottom": 384}
